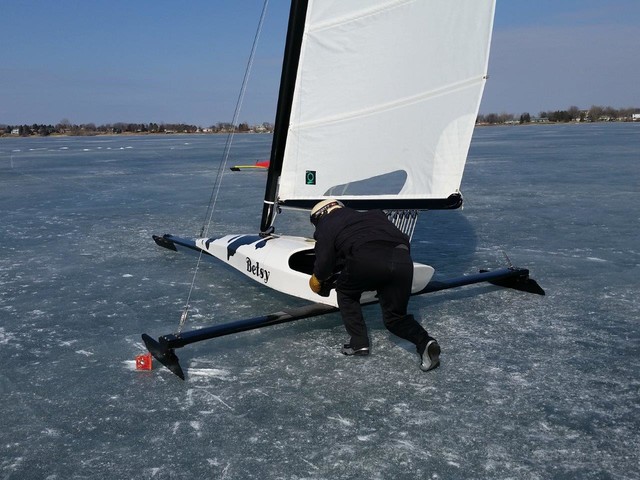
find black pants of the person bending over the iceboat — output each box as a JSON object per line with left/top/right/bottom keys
{"left": 336, "top": 244, "right": 431, "bottom": 348}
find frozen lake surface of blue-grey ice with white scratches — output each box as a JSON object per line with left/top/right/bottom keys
{"left": 0, "top": 124, "right": 640, "bottom": 480}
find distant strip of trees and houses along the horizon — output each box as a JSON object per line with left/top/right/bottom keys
{"left": 0, "top": 105, "right": 640, "bottom": 137}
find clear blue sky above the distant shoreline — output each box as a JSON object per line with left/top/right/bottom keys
{"left": 0, "top": 0, "right": 640, "bottom": 126}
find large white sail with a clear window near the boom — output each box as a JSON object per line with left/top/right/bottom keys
{"left": 278, "top": 0, "right": 495, "bottom": 205}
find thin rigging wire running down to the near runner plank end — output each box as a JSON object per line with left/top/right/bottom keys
{"left": 176, "top": 0, "right": 269, "bottom": 336}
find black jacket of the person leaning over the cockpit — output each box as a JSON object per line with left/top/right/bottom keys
{"left": 313, "top": 207, "right": 409, "bottom": 281}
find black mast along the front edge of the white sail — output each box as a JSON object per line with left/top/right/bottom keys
{"left": 260, "top": 0, "right": 308, "bottom": 232}
